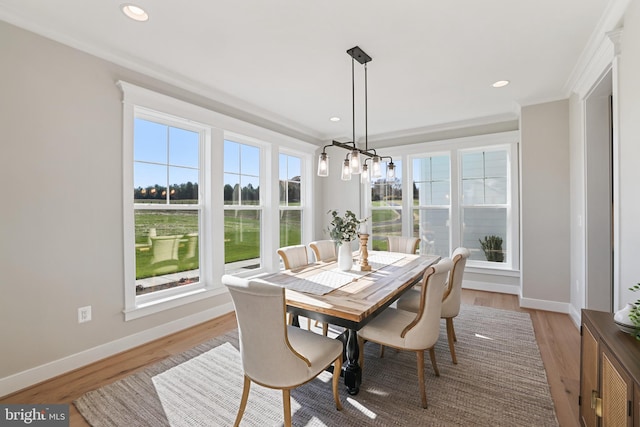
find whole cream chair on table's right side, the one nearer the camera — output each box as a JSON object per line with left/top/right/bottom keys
{"left": 358, "top": 258, "right": 453, "bottom": 408}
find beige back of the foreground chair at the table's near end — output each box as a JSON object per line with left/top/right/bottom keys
{"left": 222, "top": 275, "right": 311, "bottom": 387}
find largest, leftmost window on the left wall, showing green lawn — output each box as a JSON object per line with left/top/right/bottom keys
{"left": 133, "top": 113, "right": 204, "bottom": 296}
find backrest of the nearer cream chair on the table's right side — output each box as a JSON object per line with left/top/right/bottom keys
{"left": 401, "top": 258, "right": 453, "bottom": 349}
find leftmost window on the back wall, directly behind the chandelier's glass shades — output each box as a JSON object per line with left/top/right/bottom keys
{"left": 370, "top": 160, "right": 402, "bottom": 251}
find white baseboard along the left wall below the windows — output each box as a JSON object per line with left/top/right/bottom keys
{"left": 0, "top": 302, "right": 233, "bottom": 397}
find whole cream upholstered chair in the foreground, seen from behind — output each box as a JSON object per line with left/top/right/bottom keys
{"left": 222, "top": 275, "right": 343, "bottom": 426}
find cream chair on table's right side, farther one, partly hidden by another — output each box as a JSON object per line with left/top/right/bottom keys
{"left": 397, "top": 248, "right": 470, "bottom": 364}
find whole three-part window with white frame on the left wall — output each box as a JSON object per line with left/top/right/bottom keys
{"left": 118, "top": 81, "right": 317, "bottom": 320}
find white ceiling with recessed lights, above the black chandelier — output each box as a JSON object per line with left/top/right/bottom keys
{"left": 0, "top": 0, "right": 609, "bottom": 143}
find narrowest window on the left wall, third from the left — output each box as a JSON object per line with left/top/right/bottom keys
{"left": 278, "top": 154, "right": 302, "bottom": 247}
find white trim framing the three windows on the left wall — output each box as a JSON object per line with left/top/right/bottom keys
{"left": 116, "top": 81, "right": 317, "bottom": 321}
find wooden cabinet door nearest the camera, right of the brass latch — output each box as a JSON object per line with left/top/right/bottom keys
{"left": 600, "top": 346, "right": 633, "bottom": 427}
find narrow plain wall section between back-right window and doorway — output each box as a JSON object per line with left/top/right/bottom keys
{"left": 520, "top": 100, "right": 570, "bottom": 312}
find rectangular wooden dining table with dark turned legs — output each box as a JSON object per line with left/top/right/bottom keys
{"left": 260, "top": 251, "right": 440, "bottom": 395}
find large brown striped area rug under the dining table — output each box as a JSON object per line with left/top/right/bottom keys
{"left": 74, "top": 305, "right": 558, "bottom": 427}
